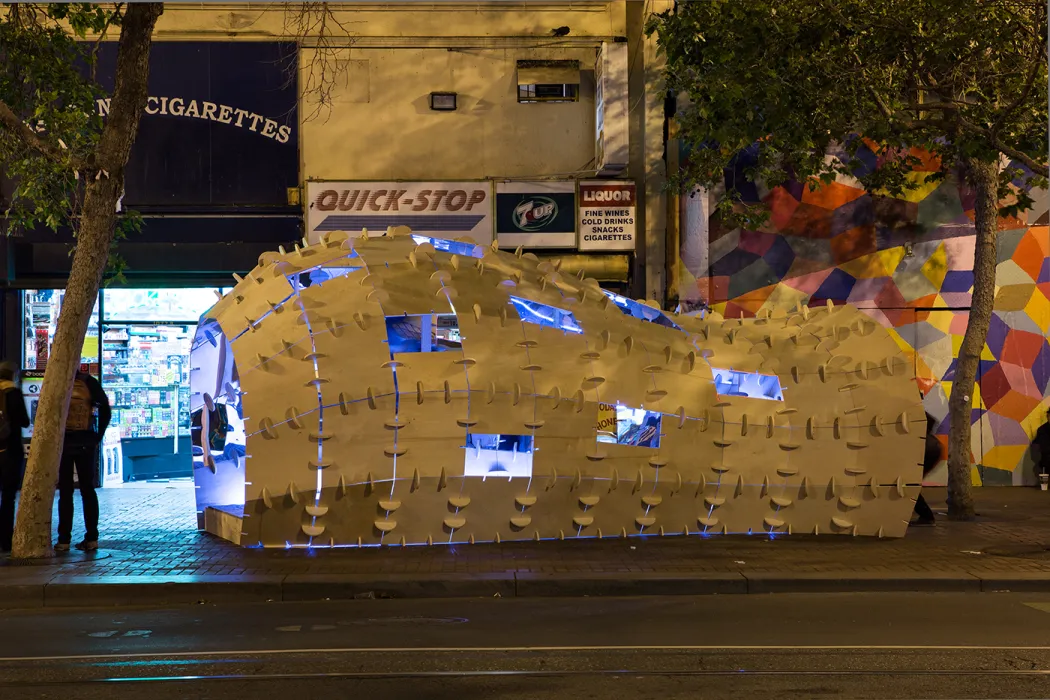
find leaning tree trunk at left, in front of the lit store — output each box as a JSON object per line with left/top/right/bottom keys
{"left": 12, "top": 3, "right": 164, "bottom": 558}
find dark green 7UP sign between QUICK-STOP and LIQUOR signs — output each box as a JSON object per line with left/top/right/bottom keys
{"left": 496, "top": 181, "right": 576, "bottom": 248}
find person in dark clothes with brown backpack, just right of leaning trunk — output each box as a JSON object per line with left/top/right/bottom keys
{"left": 55, "top": 372, "right": 110, "bottom": 552}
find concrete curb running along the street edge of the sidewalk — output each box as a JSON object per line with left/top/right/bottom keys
{"left": 0, "top": 571, "right": 1050, "bottom": 610}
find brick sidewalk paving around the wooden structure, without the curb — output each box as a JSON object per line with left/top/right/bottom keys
{"left": 37, "top": 487, "right": 1050, "bottom": 582}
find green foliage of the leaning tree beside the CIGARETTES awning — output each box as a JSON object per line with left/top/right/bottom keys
{"left": 0, "top": 3, "right": 141, "bottom": 276}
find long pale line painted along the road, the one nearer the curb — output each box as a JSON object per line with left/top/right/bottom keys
{"left": 0, "top": 644, "right": 1050, "bottom": 663}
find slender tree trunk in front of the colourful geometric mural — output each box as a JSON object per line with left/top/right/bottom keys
{"left": 948, "top": 158, "right": 999, "bottom": 521}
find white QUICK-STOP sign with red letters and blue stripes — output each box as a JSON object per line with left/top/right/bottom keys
{"left": 307, "top": 181, "right": 492, "bottom": 246}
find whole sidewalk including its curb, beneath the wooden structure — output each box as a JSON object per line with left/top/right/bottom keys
{"left": 0, "top": 487, "right": 1050, "bottom": 608}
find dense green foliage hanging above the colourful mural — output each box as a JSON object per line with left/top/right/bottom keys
{"left": 649, "top": 0, "right": 1048, "bottom": 221}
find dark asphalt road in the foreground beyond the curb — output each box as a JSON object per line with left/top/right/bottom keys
{"left": 0, "top": 593, "right": 1050, "bottom": 700}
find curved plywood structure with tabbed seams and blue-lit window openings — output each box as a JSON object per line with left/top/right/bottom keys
{"left": 193, "top": 231, "right": 926, "bottom": 547}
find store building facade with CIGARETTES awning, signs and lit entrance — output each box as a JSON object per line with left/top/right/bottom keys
{"left": 0, "top": 0, "right": 670, "bottom": 486}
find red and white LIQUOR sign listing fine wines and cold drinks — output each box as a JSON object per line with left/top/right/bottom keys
{"left": 580, "top": 179, "right": 637, "bottom": 251}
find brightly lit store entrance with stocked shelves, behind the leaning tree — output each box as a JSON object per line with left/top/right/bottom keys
{"left": 22, "top": 288, "right": 227, "bottom": 488}
